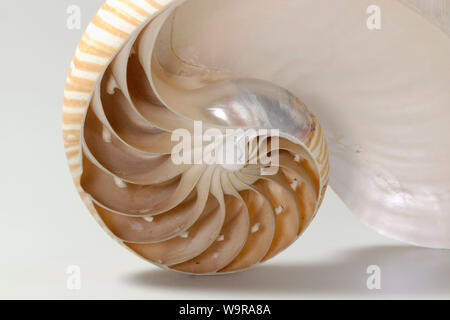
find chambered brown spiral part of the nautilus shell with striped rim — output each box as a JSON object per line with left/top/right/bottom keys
{"left": 64, "top": 1, "right": 329, "bottom": 274}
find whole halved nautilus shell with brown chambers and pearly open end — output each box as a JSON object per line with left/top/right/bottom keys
{"left": 63, "top": 0, "right": 450, "bottom": 274}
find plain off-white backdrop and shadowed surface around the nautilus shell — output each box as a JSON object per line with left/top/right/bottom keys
{"left": 0, "top": 0, "right": 450, "bottom": 299}
